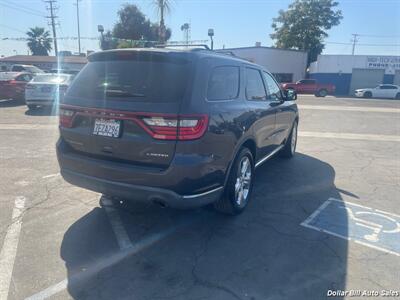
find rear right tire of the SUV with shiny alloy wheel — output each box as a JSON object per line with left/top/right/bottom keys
{"left": 214, "top": 148, "right": 254, "bottom": 215}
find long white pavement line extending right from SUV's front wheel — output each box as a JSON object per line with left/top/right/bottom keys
{"left": 298, "top": 131, "right": 400, "bottom": 142}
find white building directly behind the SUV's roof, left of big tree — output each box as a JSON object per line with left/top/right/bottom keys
{"left": 221, "top": 46, "right": 307, "bottom": 82}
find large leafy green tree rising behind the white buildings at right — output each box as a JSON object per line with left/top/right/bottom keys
{"left": 270, "top": 0, "right": 343, "bottom": 64}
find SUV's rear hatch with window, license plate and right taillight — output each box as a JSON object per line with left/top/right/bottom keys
{"left": 60, "top": 50, "right": 207, "bottom": 168}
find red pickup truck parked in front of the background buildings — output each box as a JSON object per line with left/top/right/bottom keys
{"left": 282, "top": 79, "right": 336, "bottom": 97}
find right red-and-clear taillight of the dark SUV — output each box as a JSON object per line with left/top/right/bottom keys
{"left": 141, "top": 115, "right": 208, "bottom": 141}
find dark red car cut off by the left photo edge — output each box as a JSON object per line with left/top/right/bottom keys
{"left": 0, "top": 72, "right": 33, "bottom": 101}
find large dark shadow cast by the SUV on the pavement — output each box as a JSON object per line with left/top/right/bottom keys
{"left": 61, "top": 154, "right": 348, "bottom": 300}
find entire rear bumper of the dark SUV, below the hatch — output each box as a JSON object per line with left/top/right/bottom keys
{"left": 57, "top": 138, "right": 225, "bottom": 208}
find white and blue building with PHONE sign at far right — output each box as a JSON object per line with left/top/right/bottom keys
{"left": 309, "top": 55, "right": 400, "bottom": 94}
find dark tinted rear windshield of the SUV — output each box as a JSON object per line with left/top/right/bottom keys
{"left": 68, "top": 60, "right": 189, "bottom": 103}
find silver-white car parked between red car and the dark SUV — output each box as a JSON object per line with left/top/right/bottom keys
{"left": 25, "top": 73, "right": 73, "bottom": 109}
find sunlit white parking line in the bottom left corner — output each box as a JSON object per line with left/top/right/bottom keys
{"left": 0, "top": 196, "right": 26, "bottom": 300}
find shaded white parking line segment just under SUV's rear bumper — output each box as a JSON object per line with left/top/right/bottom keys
{"left": 101, "top": 196, "right": 132, "bottom": 250}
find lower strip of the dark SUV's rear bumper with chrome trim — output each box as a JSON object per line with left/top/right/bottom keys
{"left": 61, "top": 169, "right": 223, "bottom": 209}
